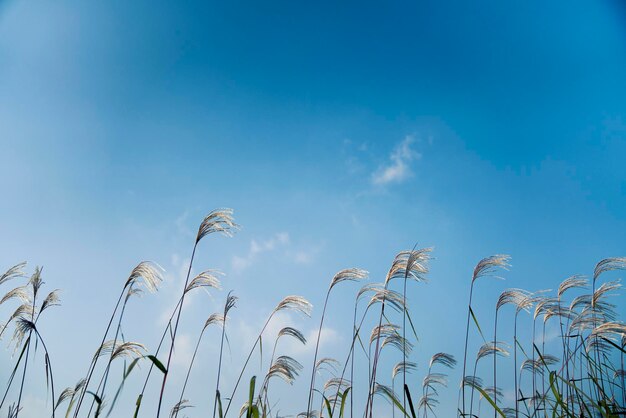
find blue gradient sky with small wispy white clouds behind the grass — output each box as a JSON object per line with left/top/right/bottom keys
{"left": 0, "top": 0, "right": 626, "bottom": 418}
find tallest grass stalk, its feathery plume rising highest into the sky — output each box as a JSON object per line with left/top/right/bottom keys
{"left": 156, "top": 209, "right": 239, "bottom": 418}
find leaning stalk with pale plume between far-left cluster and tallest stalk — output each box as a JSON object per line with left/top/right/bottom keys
{"left": 74, "top": 261, "right": 163, "bottom": 418}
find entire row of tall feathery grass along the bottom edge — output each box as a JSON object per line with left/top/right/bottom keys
{"left": 0, "top": 209, "right": 626, "bottom": 418}
